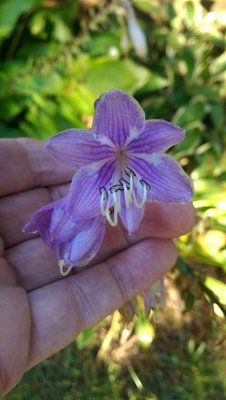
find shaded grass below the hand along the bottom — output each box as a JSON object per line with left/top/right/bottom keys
{"left": 6, "top": 282, "right": 226, "bottom": 400}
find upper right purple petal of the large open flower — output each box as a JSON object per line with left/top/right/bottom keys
{"left": 126, "top": 119, "right": 185, "bottom": 154}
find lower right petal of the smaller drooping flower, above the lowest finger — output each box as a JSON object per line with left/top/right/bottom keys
{"left": 58, "top": 216, "right": 105, "bottom": 267}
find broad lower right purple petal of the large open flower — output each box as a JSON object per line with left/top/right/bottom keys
{"left": 128, "top": 154, "right": 194, "bottom": 203}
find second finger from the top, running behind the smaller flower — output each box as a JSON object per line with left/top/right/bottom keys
{"left": 0, "top": 184, "right": 69, "bottom": 248}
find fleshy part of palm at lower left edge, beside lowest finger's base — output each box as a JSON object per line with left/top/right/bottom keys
{"left": 0, "top": 285, "right": 31, "bottom": 399}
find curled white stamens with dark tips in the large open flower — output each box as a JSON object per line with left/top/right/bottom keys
{"left": 100, "top": 168, "right": 150, "bottom": 227}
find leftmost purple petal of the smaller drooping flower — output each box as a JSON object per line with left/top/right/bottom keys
{"left": 23, "top": 200, "right": 61, "bottom": 247}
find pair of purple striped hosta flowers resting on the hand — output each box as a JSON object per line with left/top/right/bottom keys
{"left": 25, "top": 90, "right": 193, "bottom": 274}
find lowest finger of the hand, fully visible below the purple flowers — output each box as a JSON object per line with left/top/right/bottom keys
{"left": 28, "top": 239, "right": 177, "bottom": 368}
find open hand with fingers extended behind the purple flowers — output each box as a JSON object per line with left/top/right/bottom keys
{"left": 0, "top": 139, "right": 195, "bottom": 396}
